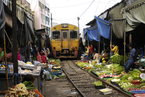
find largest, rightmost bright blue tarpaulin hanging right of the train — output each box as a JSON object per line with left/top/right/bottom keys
{"left": 95, "top": 16, "right": 111, "bottom": 39}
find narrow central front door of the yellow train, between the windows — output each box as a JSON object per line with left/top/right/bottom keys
{"left": 62, "top": 30, "right": 69, "bottom": 49}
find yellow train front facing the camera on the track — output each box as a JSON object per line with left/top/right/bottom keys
{"left": 50, "top": 23, "right": 79, "bottom": 58}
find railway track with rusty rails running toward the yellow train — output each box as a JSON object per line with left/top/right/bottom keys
{"left": 62, "top": 60, "right": 131, "bottom": 97}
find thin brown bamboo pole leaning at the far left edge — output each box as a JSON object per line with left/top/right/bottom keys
{"left": 4, "top": 34, "right": 9, "bottom": 89}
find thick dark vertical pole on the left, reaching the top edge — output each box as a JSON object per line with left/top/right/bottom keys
{"left": 12, "top": 0, "right": 18, "bottom": 85}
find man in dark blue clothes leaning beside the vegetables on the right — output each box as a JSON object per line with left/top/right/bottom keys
{"left": 124, "top": 44, "right": 136, "bottom": 73}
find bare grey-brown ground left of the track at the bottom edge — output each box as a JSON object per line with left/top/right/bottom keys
{"left": 42, "top": 78, "right": 79, "bottom": 97}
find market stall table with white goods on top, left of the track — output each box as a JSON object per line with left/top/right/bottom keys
{"left": 0, "top": 61, "right": 41, "bottom": 91}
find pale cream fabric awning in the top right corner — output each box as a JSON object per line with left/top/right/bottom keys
{"left": 122, "top": 0, "right": 145, "bottom": 32}
